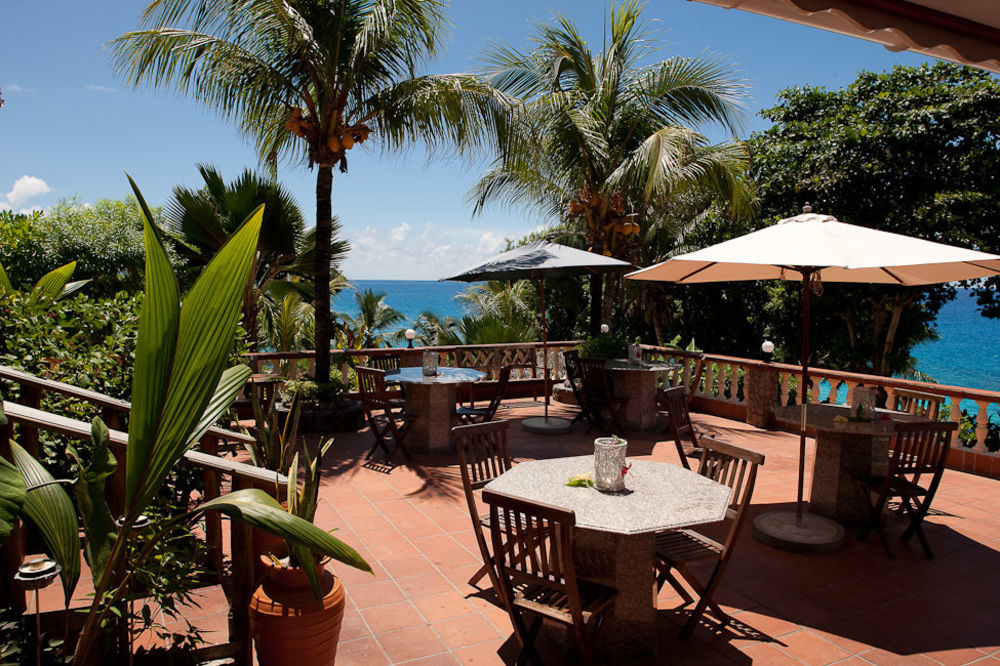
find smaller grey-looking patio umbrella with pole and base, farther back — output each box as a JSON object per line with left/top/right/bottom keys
{"left": 440, "top": 241, "right": 635, "bottom": 433}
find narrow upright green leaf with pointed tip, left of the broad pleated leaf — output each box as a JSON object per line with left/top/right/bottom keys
{"left": 125, "top": 177, "right": 180, "bottom": 513}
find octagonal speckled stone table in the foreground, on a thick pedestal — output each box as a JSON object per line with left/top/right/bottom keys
{"left": 486, "top": 456, "right": 731, "bottom": 663}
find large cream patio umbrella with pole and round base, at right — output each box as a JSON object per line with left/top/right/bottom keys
{"left": 626, "top": 204, "right": 1000, "bottom": 550}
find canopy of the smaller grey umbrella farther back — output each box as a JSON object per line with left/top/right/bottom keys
{"left": 441, "top": 241, "right": 634, "bottom": 282}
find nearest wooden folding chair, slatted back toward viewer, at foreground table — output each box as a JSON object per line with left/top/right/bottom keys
{"left": 483, "top": 489, "right": 618, "bottom": 664}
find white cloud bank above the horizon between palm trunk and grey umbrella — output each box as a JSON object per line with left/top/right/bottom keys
{"left": 341, "top": 222, "right": 520, "bottom": 280}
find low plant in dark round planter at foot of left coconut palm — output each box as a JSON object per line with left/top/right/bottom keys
{"left": 277, "top": 369, "right": 364, "bottom": 432}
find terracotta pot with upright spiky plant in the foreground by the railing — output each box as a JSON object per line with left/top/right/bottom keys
{"left": 250, "top": 439, "right": 346, "bottom": 666}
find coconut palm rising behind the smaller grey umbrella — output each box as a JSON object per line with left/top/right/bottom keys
{"left": 469, "top": 0, "right": 752, "bottom": 334}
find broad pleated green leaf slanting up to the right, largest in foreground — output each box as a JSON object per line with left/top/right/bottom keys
{"left": 126, "top": 202, "right": 263, "bottom": 514}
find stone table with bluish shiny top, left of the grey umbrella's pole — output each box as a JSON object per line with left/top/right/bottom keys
{"left": 385, "top": 366, "right": 486, "bottom": 454}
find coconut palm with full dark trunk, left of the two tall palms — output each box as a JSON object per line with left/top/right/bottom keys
{"left": 111, "top": 0, "right": 508, "bottom": 382}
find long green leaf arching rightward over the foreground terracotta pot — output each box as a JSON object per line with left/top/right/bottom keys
{"left": 197, "top": 488, "right": 372, "bottom": 573}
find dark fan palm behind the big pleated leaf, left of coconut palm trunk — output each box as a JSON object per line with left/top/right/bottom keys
{"left": 163, "top": 164, "right": 350, "bottom": 349}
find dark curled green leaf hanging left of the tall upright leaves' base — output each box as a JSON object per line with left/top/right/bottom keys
{"left": 68, "top": 418, "right": 118, "bottom": 579}
